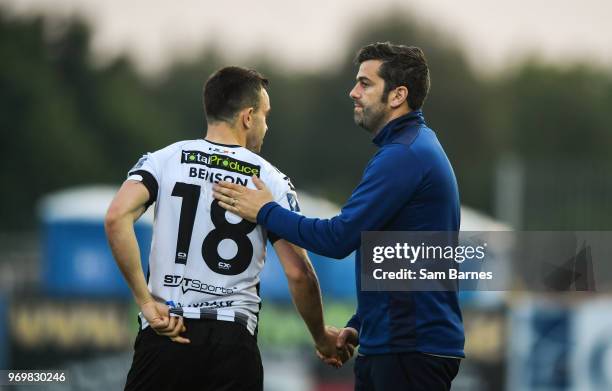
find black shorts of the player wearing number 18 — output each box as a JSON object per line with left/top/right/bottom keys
{"left": 125, "top": 319, "right": 263, "bottom": 391}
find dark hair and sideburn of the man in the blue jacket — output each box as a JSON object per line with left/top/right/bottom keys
{"left": 355, "top": 42, "right": 429, "bottom": 110}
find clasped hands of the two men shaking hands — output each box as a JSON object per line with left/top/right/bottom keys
{"left": 315, "top": 326, "right": 359, "bottom": 368}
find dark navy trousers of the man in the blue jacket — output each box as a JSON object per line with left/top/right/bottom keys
{"left": 355, "top": 352, "right": 461, "bottom": 391}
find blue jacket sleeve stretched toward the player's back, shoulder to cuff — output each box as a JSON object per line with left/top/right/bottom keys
{"left": 257, "top": 144, "right": 424, "bottom": 259}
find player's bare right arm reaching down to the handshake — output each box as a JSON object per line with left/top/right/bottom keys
{"left": 274, "top": 239, "right": 348, "bottom": 366}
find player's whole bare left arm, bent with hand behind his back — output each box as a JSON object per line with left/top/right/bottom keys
{"left": 104, "top": 180, "right": 189, "bottom": 343}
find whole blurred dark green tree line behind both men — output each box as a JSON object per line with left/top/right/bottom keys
{"left": 0, "top": 7, "right": 612, "bottom": 230}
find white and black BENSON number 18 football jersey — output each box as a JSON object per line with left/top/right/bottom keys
{"left": 127, "top": 139, "right": 299, "bottom": 334}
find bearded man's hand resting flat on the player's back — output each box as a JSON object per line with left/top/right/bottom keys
{"left": 213, "top": 175, "right": 274, "bottom": 223}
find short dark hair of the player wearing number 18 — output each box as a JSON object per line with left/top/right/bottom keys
{"left": 203, "top": 66, "right": 268, "bottom": 123}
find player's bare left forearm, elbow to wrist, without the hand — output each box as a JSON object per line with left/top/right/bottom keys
{"left": 105, "top": 216, "right": 152, "bottom": 306}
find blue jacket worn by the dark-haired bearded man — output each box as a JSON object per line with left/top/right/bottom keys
{"left": 257, "top": 110, "right": 464, "bottom": 357}
